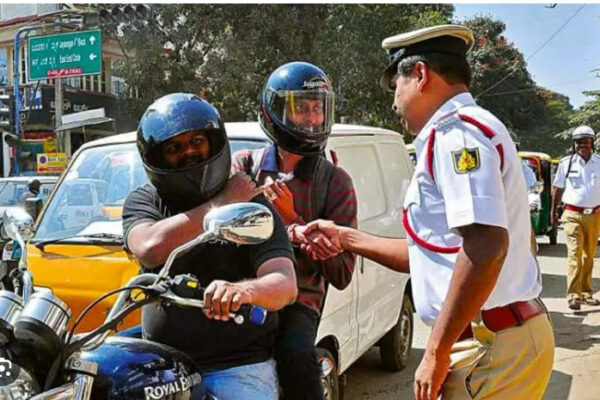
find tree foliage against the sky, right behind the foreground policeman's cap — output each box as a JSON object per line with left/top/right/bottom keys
{"left": 463, "top": 16, "right": 572, "bottom": 154}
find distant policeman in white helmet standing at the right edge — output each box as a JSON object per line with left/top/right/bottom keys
{"left": 551, "top": 125, "right": 600, "bottom": 310}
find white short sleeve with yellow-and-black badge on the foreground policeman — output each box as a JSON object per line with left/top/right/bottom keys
{"left": 433, "top": 125, "right": 508, "bottom": 229}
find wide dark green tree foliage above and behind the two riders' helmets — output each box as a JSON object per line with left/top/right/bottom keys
{"left": 111, "top": 4, "right": 453, "bottom": 128}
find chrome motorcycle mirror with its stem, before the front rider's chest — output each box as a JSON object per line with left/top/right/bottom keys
{"left": 156, "top": 203, "right": 273, "bottom": 282}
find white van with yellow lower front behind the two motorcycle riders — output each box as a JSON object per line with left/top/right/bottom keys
{"left": 28, "top": 122, "right": 413, "bottom": 399}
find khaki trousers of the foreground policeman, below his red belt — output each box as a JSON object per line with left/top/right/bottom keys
{"left": 441, "top": 314, "right": 554, "bottom": 400}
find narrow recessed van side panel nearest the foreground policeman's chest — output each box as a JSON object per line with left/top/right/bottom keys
{"left": 379, "top": 142, "right": 413, "bottom": 209}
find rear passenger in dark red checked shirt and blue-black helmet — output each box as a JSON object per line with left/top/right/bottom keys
{"left": 232, "top": 62, "right": 357, "bottom": 400}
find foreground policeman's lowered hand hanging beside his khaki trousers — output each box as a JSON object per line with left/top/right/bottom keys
{"left": 414, "top": 350, "right": 450, "bottom": 400}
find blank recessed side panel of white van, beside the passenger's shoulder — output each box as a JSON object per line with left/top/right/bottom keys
{"left": 334, "top": 144, "right": 386, "bottom": 221}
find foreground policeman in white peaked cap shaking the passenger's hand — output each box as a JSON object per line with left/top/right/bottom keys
{"left": 304, "top": 25, "right": 554, "bottom": 400}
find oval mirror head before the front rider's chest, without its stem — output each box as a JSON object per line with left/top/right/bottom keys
{"left": 204, "top": 203, "right": 273, "bottom": 244}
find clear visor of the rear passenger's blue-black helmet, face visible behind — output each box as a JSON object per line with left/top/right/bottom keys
{"left": 266, "top": 90, "right": 334, "bottom": 139}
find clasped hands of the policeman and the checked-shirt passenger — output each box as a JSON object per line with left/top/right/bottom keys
{"left": 288, "top": 219, "right": 344, "bottom": 260}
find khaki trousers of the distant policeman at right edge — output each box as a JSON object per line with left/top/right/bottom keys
{"left": 562, "top": 210, "right": 600, "bottom": 299}
